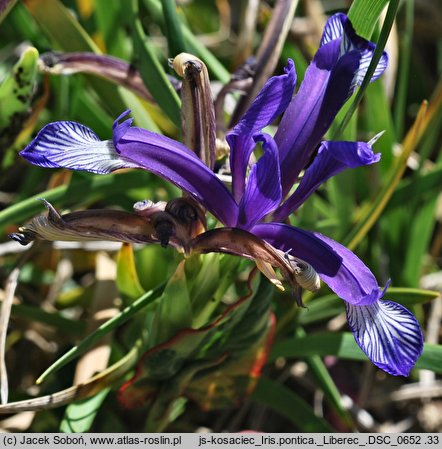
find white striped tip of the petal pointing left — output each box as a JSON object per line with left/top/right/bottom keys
{"left": 20, "top": 121, "right": 137, "bottom": 174}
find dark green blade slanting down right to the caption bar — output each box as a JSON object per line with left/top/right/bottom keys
{"left": 252, "top": 377, "right": 334, "bottom": 433}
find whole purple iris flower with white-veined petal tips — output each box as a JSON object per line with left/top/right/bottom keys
{"left": 21, "top": 14, "right": 423, "bottom": 375}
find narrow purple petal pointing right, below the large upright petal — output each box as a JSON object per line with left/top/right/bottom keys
{"left": 274, "top": 142, "right": 381, "bottom": 221}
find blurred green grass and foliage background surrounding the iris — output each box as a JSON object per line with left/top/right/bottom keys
{"left": 0, "top": 0, "right": 442, "bottom": 432}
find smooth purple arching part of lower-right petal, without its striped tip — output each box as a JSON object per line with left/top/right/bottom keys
{"left": 251, "top": 223, "right": 382, "bottom": 305}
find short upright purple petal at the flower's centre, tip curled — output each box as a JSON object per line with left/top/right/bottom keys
{"left": 237, "top": 134, "right": 281, "bottom": 229}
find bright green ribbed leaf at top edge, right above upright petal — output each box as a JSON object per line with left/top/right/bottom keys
{"left": 348, "top": 0, "right": 389, "bottom": 39}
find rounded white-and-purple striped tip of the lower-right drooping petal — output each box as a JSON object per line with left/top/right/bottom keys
{"left": 346, "top": 301, "right": 423, "bottom": 376}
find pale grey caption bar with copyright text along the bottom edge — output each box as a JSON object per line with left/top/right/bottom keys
{"left": 0, "top": 432, "right": 442, "bottom": 449}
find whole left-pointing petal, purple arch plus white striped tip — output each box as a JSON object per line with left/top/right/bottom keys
{"left": 20, "top": 111, "right": 238, "bottom": 226}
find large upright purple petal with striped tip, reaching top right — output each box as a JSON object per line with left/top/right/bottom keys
{"left": 275, "top": 14, "right": 388, "bottom": 195}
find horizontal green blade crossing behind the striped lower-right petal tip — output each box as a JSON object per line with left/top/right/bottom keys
{"left": 268, "top": 332, "right": 442, "bottom": 374}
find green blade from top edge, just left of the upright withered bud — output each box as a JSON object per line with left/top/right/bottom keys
{"left": 130, "top": 0, "right": 181, "bottom": 129}
